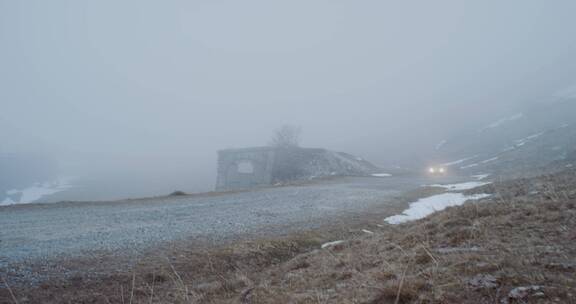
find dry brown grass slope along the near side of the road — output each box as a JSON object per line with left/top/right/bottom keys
{"left": 0, "top": 171, "right": 576, "bottom": 304}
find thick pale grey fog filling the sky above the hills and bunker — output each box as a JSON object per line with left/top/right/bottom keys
{"left": 0, "top": 0, "right": 576, "bottom": 199}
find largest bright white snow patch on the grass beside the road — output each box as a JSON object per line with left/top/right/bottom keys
{"left": 384, "top": 193, "right": 490, "bottom": 224}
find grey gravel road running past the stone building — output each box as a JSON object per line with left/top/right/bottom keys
{"left": 0, "top": 177, "right": 452, "bottom": 266}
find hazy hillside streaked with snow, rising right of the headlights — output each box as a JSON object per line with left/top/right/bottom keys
{"left": 434, "top": 97, "right": 576, "bottom": 175}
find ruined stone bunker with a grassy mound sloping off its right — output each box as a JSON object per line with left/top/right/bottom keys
{"left": 216, "top": 147, "right": 380, "bottom": 191}
